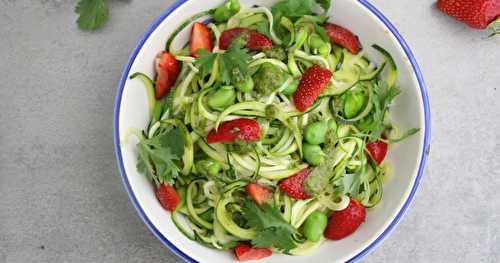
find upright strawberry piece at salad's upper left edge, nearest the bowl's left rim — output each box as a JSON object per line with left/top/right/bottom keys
{"left": 155, "top": 52, "right": 180, "bottom": 99}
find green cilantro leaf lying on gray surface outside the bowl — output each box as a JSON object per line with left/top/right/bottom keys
{"left": 75, "top": 0, "right": 109, "bottom": 30}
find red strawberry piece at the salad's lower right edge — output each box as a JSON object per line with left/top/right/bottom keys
{"left": 324, "top": 198, "right": 366, "bottom": 240}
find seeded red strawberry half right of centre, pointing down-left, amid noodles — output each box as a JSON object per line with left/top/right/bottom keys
{"left": 293, "top": 65, "right": 332, "bottom": 112}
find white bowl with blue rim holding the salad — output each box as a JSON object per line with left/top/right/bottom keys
{"left": 114, "top": 0, "right": 431, "bottom": 263}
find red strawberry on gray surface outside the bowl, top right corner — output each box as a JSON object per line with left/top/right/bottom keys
{"left": 437, "top": 0, "right": 500, "bottom": 29}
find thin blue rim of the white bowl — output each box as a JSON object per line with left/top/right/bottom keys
{"left": 113, "top": 0, "right": 431, "bottom": 262}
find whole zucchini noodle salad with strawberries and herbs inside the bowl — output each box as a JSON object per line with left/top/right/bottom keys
{"left": 115, "top": 0, "right": 428, "bottom": 261}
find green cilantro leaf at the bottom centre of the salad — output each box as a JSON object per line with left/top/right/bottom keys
{"left": 243, "top": 200, "right": 297, "bottom": 250}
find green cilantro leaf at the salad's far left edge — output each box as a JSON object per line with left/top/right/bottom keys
{"left": 137, "top": 129, "right": 184, "bottom": 185}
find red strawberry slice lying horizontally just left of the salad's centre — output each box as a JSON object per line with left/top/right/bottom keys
{"left": 207, "top": 118, "right": 260, "bottom": 144}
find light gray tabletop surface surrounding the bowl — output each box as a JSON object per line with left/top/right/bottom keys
{"left": 0, "top": 0, "right": 500, "bottom": 263}
